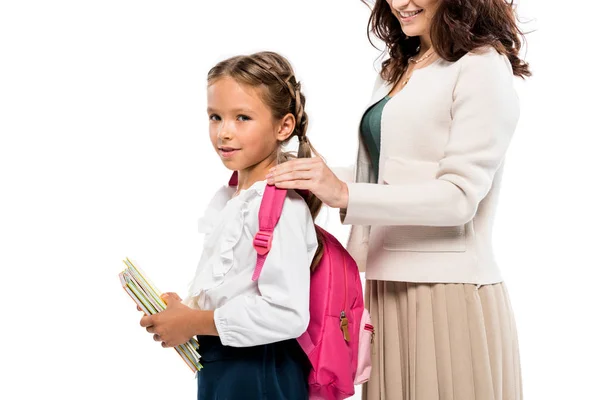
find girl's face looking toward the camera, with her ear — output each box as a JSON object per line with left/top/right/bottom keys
{"left": 207, "top": 77, "right": 294, "bottom": 171}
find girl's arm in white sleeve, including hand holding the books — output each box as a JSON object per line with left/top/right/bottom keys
{"left": 140, "top": 192, "right": 317, "bottom": 347}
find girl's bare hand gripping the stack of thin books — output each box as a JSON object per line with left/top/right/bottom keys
{"left": 140, "top": 293, "right": 197, "bottom": 347}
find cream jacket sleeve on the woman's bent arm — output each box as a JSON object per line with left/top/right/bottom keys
{"left": 342, "top": 50, "right": 519, "bottom": 226}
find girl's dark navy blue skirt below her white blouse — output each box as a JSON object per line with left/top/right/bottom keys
{"left": 197, "top": 336, "right": 310, "bottom": 400}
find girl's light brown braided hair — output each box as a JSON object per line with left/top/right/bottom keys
{"left": 208, "top": 51, "right": 323, "bottom": 270}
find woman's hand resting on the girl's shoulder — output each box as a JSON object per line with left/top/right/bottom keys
{"left": 267, "top": 157, "right": 348, "bottom": 208}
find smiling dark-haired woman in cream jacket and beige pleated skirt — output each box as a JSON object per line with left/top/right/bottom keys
{"left": 267, "top": 0, "right": 530, "bottom": 400}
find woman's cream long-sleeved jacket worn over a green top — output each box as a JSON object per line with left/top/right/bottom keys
{"left": 341, "top": 48, "right": 519, "bottom": 284}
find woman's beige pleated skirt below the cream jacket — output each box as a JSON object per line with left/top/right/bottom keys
{"left": 362, "top": 281, "right": 523, "bottom": 400}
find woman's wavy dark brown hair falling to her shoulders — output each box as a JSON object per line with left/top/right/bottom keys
{"left": 362, "top": 0, "right": 531, "bottom": 83}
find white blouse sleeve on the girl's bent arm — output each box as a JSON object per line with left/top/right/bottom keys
{"left": 214, "top": 193, "right": 317, "bottom": 347}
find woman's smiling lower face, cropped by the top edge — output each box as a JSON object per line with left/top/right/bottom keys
{"left": 387, "top": 0, "right": 441, "bottom": 36}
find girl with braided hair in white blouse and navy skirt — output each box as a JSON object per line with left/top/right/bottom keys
{"left": 141, "top": 52, "right": 321, "bottom": 400}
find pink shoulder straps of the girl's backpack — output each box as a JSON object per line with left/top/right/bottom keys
{"left": 229, "top": 171, "right": 287, "bottom": 281}
